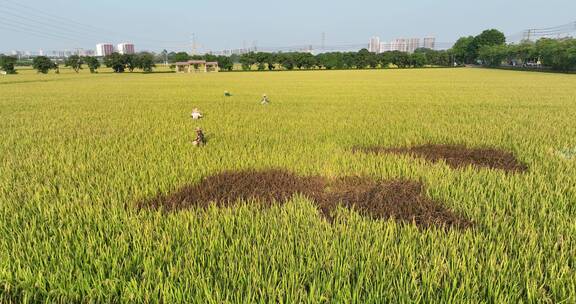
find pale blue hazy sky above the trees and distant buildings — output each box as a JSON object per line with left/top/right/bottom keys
{"left": 0, "top": 0, "right": 576, "bottom": 51}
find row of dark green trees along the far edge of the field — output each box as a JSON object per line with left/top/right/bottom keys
{"left": 0, "top": 29, "right": 576, "bottom": 74}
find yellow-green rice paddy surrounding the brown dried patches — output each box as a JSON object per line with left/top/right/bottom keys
{"left": 0, "top": 68, "right": 576, "bottom": 303}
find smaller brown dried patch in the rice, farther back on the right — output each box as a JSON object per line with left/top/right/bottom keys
{"left": 353, "top": 144, "right": 528, "bottom": 172}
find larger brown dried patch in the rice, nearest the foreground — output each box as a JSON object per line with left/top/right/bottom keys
{"left": 140, "top": 170, "right": 471, "bottom": 229}
